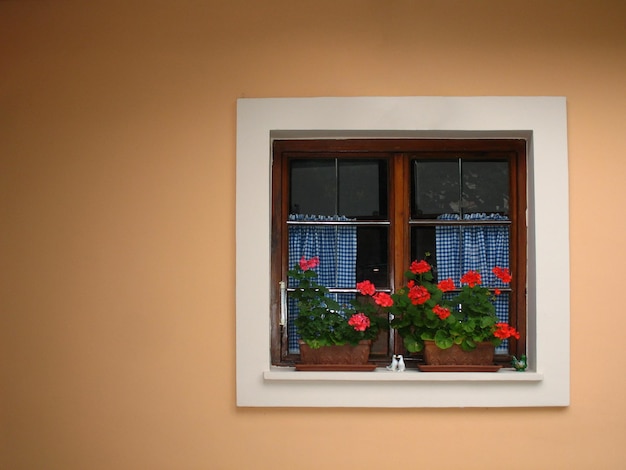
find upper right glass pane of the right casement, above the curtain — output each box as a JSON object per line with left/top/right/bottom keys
{"left": 461, "top": 161, "right": 509, "bottom": 215}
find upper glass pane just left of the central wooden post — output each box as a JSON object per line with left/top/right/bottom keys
{"left": 338, "top": 159, "right": 388, "bottom": 218}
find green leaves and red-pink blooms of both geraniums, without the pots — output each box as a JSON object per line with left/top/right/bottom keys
{"left": 288, "top": 258, "right": 519, "bottom": 353}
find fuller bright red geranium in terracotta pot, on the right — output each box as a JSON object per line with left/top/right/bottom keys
{"left": 361, "top": 260, "right": 519, "bottom": 365}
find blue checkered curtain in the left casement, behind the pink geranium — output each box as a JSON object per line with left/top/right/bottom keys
{"left": 287, "top": 214, "right": 357, "bottom": 353}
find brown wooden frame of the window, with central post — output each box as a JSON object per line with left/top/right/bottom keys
{"left": 270, "top": 139, "right": 527, "bottom": 366}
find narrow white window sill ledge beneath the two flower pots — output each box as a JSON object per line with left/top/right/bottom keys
{"left": 263, "top": 367, "right": 543, "bottom": 382}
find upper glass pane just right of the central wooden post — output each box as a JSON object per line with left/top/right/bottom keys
{"left": 411, "top": 159, "right": 460, "bottom": 219}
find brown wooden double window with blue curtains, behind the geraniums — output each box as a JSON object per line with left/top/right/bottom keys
{"left": 271, "top": 139, "right": 526, "bottom": 365}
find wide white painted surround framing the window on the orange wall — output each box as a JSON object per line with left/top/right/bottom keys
{"left": 236, "top": 97, "right": 570, "bottom": 407}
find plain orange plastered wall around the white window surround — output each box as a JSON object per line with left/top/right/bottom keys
{"left": 0, "top": 0, "right": 626, "bottom": 470}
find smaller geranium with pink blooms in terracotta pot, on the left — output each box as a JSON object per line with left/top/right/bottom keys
{"left": 288, "top": 257, "right": 388, "bottom": 364}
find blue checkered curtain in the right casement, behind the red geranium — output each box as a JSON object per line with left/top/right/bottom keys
{"left": 435, "top": 213, "right": 509, "bottom": 352}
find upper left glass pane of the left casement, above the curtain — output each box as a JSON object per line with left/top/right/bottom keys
{"left": 289, "top": 158, "right": 337, "bottom": 215}
